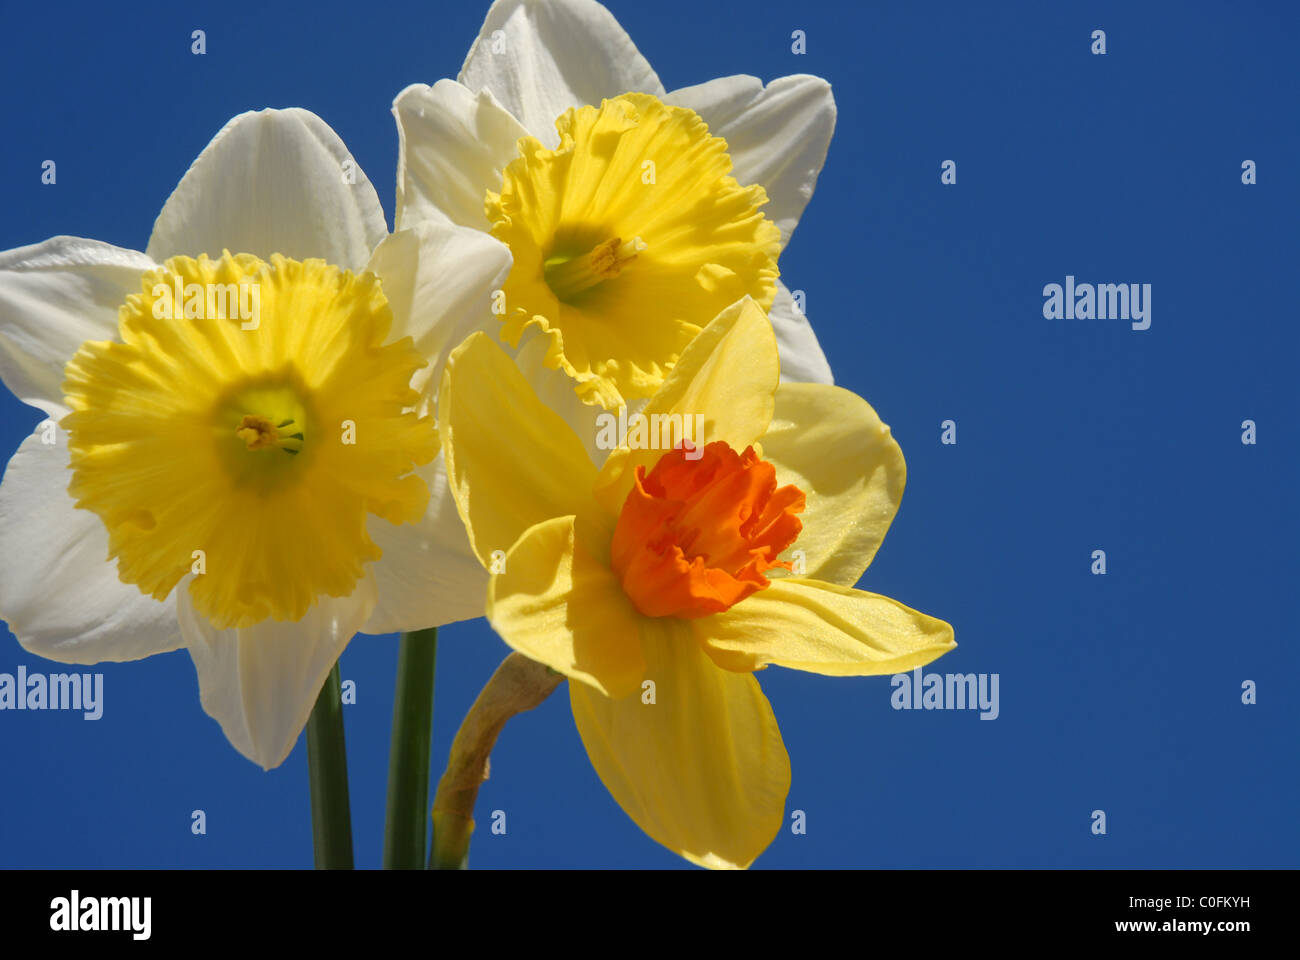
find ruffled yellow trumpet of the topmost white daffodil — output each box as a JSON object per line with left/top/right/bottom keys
{"left": 486, "top": 94, "right": 780, "bottom": 410}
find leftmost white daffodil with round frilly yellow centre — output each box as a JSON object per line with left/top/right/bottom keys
{"left": 0, "top": 109, "right": 511, "bottom": 769}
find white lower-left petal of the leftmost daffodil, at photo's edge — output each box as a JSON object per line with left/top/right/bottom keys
{"left": 0, "top": 428, "right": 182, "bottom": 663}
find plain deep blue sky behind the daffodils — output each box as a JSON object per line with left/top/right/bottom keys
{"left": 0, "top": 0, "right": 1300, "bottom": 868}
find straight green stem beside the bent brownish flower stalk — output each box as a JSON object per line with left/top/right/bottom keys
{"left": 384, "top": 627, "right": 438, "bottom": 870}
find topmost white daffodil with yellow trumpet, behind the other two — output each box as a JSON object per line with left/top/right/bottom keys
{"left": 393, "top": 0, "right": 836, "bottom": 411}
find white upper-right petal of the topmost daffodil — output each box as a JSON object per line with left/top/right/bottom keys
{"left": 667, "top": 74, "right": 835, "bottom": 243}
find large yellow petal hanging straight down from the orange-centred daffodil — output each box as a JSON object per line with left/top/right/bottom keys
{"left": 569, "top": 619, "right": 790, "bottom": 868}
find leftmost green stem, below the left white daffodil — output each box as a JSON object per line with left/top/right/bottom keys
{"left": 307, "top": 663, "right": 352, "bottom": 870}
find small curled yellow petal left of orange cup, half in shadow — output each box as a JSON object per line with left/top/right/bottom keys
{"left": 488, "top": 516, "right": 646, "bottom": 697}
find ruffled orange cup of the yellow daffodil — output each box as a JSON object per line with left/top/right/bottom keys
{"left": 610, "top": 441, "right": 805, "bottom": 618}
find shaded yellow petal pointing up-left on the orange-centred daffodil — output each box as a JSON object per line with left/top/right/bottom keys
{"left": 438, "top": 333, "right": 595, "bottom": 570}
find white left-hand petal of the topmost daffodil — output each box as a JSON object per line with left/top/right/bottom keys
{"left": 393, "top": 79, "right": 528, "bottom": 230}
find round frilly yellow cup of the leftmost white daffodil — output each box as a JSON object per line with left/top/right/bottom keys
{"left": 64, "top": 252, "right": 437, "bottom": 628}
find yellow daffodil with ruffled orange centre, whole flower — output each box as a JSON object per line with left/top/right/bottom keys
{"left": 438, "top": 299, "right": 954, "bottom": 866}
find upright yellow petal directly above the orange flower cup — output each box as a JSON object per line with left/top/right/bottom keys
{"left": 595, "top": 297, "right": 780, "bottom": 514}
